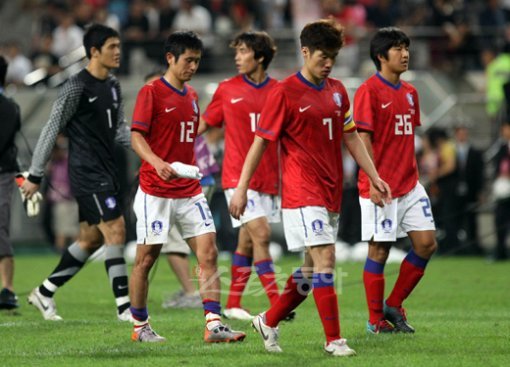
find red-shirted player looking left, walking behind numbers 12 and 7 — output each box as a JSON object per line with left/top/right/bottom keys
{"left": 203, "top": 32, "right": 280, "bottom": 320}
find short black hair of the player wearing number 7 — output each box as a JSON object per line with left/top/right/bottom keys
{"left": 299, "top": 19, "right": 344, "bottom": 53}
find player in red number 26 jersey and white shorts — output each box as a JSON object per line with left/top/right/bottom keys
{"left": 354, "top": 28, "right": 437, "bottom": 333}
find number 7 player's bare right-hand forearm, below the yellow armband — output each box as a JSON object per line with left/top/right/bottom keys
{"left": 344, "top": 130, "right": 391, "bottom": 206}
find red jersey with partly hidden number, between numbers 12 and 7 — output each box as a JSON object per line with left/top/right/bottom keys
{"left": 203, "top": 75, "right": 278, "bottom": 195}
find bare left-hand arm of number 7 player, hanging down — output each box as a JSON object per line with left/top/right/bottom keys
{"left": 229, "top": 135, "right": 269, "bottom": 219}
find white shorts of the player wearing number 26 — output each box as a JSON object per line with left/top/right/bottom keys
{"left": 359, "top": 182, "right": 436, "bottom": 242}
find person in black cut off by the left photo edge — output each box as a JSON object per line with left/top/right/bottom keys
{"left": 0, "top": 56, "right": 21, "bottom": 309}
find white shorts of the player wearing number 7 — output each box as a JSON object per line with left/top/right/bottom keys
{"left": 282, "top": 206, "right": 340, "bottom": 251}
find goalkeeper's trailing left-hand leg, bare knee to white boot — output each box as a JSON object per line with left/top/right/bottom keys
{"left": 28, "top": 221, "right": 103, "bottom": 321}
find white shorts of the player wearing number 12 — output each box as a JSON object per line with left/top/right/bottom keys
{"left": 133, "top": 187, "right": 216, "bottom": 245}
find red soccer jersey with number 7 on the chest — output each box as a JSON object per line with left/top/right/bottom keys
{"left": 257, "top": 73, "right": 356, "bottom": 213}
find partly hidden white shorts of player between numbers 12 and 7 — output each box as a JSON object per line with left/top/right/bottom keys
{"left": 225, "top": 189, "right": 281, "bottom": 228}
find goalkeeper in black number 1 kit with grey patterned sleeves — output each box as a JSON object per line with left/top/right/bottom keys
{"left": 21, "top": 24, "right": 131, "bottom": 321}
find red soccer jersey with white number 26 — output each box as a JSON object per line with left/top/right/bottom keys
{"left": 354, "top": 73, "right": 420, "bottom": 198}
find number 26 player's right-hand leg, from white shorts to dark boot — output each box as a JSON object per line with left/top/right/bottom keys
{"left": 384, "top": 184, "right": 437, "bottom": 333}
